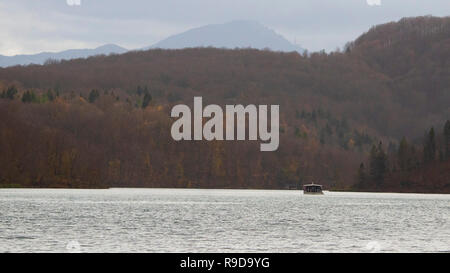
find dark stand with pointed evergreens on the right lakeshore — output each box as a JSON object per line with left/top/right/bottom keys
{"left": 354, "top": 120, "right": 450, "bottom": 192}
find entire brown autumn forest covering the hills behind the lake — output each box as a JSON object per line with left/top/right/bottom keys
{"left": 0, "top": 17, "right": 450, "bottom": 193}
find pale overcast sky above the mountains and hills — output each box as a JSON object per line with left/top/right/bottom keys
{"left": 0, "top": 0, "right": 450, "bottom": 55}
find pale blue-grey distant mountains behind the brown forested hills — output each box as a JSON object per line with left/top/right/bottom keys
{"left": 0, "top": 21, "right": 304, "bottom": 67}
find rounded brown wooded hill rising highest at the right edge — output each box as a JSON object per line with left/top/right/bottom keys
{"left": 347, "top": 16, "right": 450, "bottom": 115}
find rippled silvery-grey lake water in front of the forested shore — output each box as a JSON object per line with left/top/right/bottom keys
{"left": 0, "top": 189, "right": 450, "bottom": 252}
